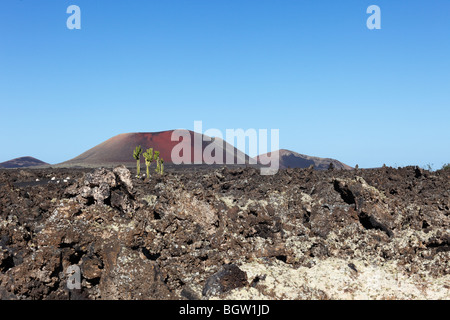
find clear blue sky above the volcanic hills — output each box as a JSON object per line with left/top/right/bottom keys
{"left": 0, "top": 0, "right": 450, "bottom": 167}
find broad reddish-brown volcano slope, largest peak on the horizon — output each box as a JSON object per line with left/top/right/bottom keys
{"left": 60, "top": 130, "right": 249, "bottom": 166}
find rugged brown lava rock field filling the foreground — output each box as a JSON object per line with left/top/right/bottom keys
{"left": 0, "top": 166, "right": 450, "bottom": 299}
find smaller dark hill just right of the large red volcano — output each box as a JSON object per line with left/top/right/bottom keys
{"left": 256, "top": 149, "right": 353, "bottom": 170}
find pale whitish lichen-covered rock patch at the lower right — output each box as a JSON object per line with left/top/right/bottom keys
{"left": 221, "top": 258, "right": 450, "bottom": 300}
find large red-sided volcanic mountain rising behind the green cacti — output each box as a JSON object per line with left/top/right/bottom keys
{"left": 58, "top": 130, "right": 249, "bottom": 167}
